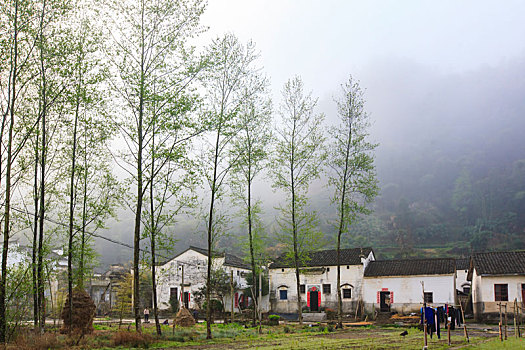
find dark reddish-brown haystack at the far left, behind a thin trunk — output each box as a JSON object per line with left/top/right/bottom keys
{"left": 60, "top": 289, "right": 96, "bottom": 334}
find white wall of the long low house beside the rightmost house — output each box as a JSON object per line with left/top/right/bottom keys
{"left": 363, "top": 274, "right": 456, "bottom": 314}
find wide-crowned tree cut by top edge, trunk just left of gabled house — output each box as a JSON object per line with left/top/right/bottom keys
{"left": 104, "top": 0, "right": 205, "bottom": 332}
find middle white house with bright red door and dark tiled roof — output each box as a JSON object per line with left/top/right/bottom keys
{"left": 269, "top": 248, "right": 375, "bottom": 313}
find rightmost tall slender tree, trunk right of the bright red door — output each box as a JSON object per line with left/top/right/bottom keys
{"left": 328, "top": 77, "right": 379, "bottom": 327}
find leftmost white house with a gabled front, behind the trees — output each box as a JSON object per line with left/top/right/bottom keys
{"left": 157, "top": 246, "right": 250, "bottom": 311}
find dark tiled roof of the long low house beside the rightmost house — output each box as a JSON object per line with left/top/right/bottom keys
{"left": 364, "top": 258, "right": 456, "bottom": 277}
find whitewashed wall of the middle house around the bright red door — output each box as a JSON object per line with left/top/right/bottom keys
{"left": 270, "top": 252, "right": 374, "bottom": 313}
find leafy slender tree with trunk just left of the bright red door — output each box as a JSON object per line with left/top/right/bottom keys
{"left": 272, "top": 77, "right": 326, "bottom": 323}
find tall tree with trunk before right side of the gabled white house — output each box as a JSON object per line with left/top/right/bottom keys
{"left": 200, "top": 34, "right": 264, "bottom": 339}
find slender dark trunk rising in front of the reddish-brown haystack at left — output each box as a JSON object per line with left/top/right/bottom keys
{"left": 67, "top": 79, "right": 82, "bottom": 333}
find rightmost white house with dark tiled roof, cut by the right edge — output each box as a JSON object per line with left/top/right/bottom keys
{"left": 468, "top": 250, "right": 525, "bottom": 320}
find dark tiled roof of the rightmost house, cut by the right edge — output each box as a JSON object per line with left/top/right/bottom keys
{"left": 472, "top": 250, "right": 525, "bottom": 275}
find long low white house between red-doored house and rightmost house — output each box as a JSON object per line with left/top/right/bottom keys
{"left": 363, "top": 258, "right": 456, "bottom": 313}
